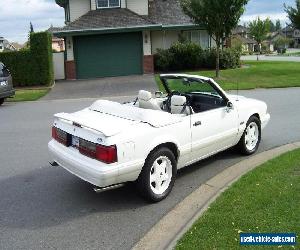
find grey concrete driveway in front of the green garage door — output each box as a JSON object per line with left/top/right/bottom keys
{"left": 42, "top": 75, "right": 157, "bottom": 100}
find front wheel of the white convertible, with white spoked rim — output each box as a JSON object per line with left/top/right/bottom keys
{"left": 238, "top": 116, "right": 261, "bottom": 155}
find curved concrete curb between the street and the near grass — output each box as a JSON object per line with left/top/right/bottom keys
{"left": 132, "top": 142, "right": 300, "bottom": 250}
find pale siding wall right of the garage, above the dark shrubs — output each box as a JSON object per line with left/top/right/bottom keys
{"left": 151, "top": 30, "right": 180, "bottom": 54}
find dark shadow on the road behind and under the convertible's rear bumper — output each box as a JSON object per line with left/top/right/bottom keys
{"left": 0, "top": 167, "right": 148, "bottom": 229}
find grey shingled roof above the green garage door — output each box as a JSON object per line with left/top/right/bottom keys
{"left": 53, "top": 0, "right": 199, "bottom": 36}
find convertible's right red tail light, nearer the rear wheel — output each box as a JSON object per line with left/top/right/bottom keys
{"left": 79, "top": 138, "right": 117, "bottom": 164}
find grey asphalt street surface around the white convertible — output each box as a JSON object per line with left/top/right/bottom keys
{"left": 0, "top": 88, "right": 300, "bottom": 249}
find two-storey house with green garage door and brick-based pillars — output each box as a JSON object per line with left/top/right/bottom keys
{"left": 54, "top": 0, "right": 212, "bottom": 79}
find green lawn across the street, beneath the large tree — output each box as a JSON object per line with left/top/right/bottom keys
{"left": 156, "top": 61, "right": 300, "bottom": 90}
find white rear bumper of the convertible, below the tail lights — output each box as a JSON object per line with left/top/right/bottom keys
{"left": 48, "top": 140, "right": 143, "bottom": 187}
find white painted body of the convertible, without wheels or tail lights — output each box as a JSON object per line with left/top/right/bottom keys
{"left": 48, "top": 75, "right": 270, "bottom": 187}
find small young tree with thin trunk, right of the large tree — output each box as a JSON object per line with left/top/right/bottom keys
{"left": 249, "top": 17, "right": 270, "bottom": 60}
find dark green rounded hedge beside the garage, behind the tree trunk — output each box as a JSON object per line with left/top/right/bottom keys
{"left": 154, "top": 42, "right": 241, "bottom": 71}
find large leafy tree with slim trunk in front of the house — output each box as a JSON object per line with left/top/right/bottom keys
{"left": 181, "top": 0, "right": 249, "bottom": 77}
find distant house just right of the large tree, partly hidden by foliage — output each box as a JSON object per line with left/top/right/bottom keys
{"left": 231, "top": 25, "right": 256, "bottom": 52}
